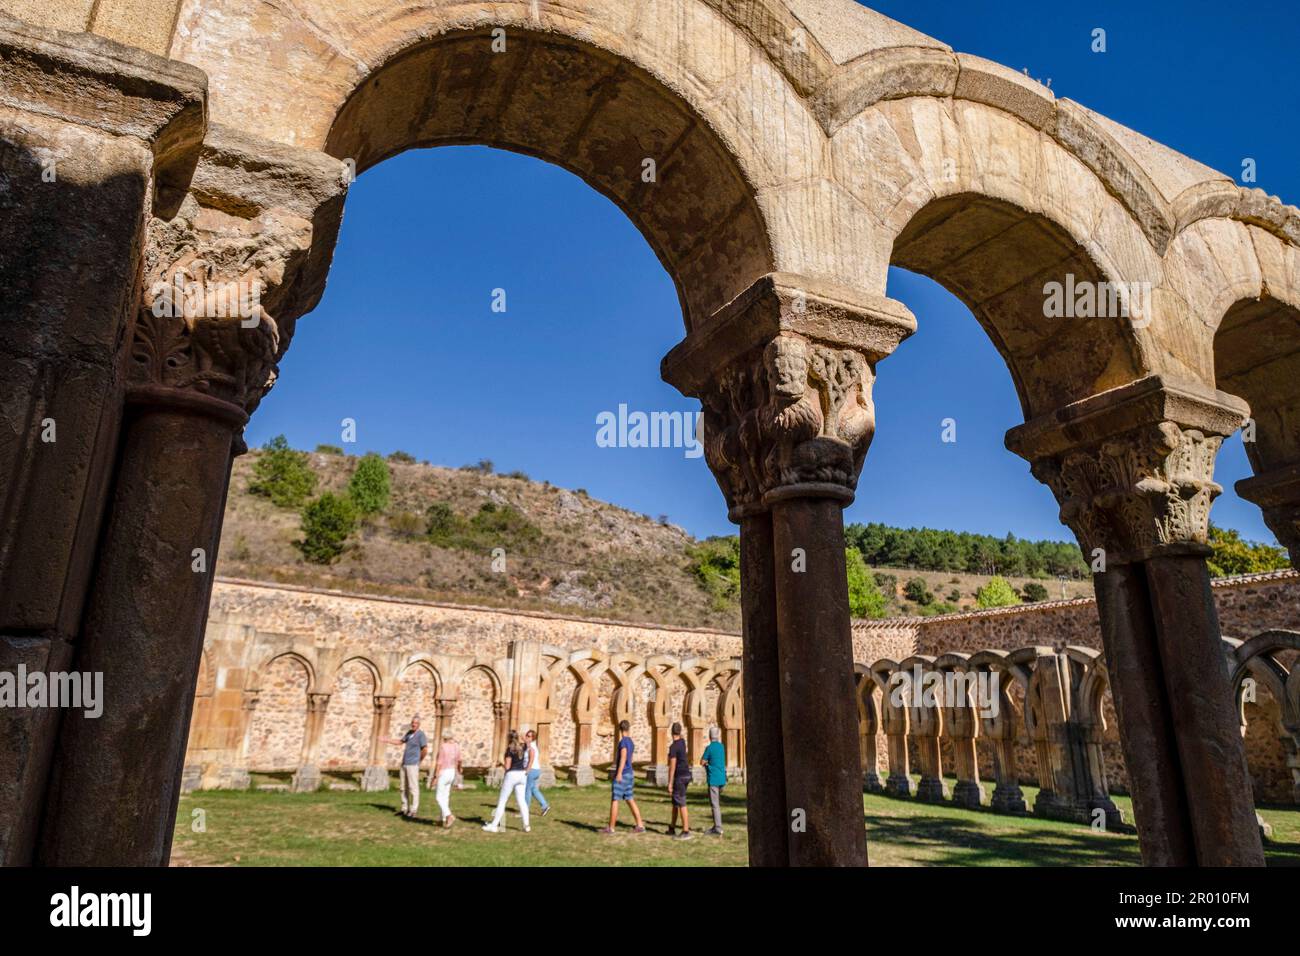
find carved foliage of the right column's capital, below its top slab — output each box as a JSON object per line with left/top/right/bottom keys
{"left": 1032, "top": 421, "right": 1223, "bottom": 561}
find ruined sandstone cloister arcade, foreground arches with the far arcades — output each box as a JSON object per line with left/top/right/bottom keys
{"left": 0, "top": 0, "right": 1300, "bottom": 865}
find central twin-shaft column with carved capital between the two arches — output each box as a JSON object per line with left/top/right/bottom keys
{"left": 663, "top": 274, "right": 915, "bottom": 866}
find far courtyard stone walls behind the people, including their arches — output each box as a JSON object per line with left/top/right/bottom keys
{"left": 186, "top": 571, "right": 1300, "bottom": 818}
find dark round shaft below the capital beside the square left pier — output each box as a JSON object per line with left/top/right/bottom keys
{"left": 39, "top": 393, "right": 244, "bottom": 866}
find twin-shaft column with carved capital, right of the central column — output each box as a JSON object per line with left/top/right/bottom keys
{"left": 1008, "top": 376, "right": 1264, "bottom": 866}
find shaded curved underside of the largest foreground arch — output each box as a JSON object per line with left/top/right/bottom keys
{"left": 321, "top": 16, "right": 775, "bottom": 329}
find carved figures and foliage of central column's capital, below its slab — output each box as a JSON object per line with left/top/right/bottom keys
{"left": 701, "top": 332, "right": 875, "bottom": 518}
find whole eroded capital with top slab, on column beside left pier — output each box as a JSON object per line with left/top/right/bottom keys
{"left": 129, "top": 126, "right": 346, "bottom": 426}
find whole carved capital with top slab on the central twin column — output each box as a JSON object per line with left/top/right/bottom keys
{"left": 663, "top": 274, "right": 917, "bottom": 520}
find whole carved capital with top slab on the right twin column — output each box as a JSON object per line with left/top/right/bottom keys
{"left": 1006, "top": 376, "right": 1247, "bottom": 563}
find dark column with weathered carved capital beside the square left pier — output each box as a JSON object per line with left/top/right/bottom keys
{"left": 35, "top": 115, "right": 343, "bottom": 865}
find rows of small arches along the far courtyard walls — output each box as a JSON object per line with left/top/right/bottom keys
{"left": 183, "top": 616, "right": 1300, "bottom": 829}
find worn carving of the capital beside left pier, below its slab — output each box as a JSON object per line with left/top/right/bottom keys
{"left": 130, "top": 196, "right": 311, "bottom": 412}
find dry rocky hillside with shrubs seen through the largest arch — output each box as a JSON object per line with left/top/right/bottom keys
{"left": 217, "top": 451, "right": 740, "bottom": 630}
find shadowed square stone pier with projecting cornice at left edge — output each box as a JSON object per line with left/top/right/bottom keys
{"left": 0, "top": 13, "right": 207, "bottom": 866}
